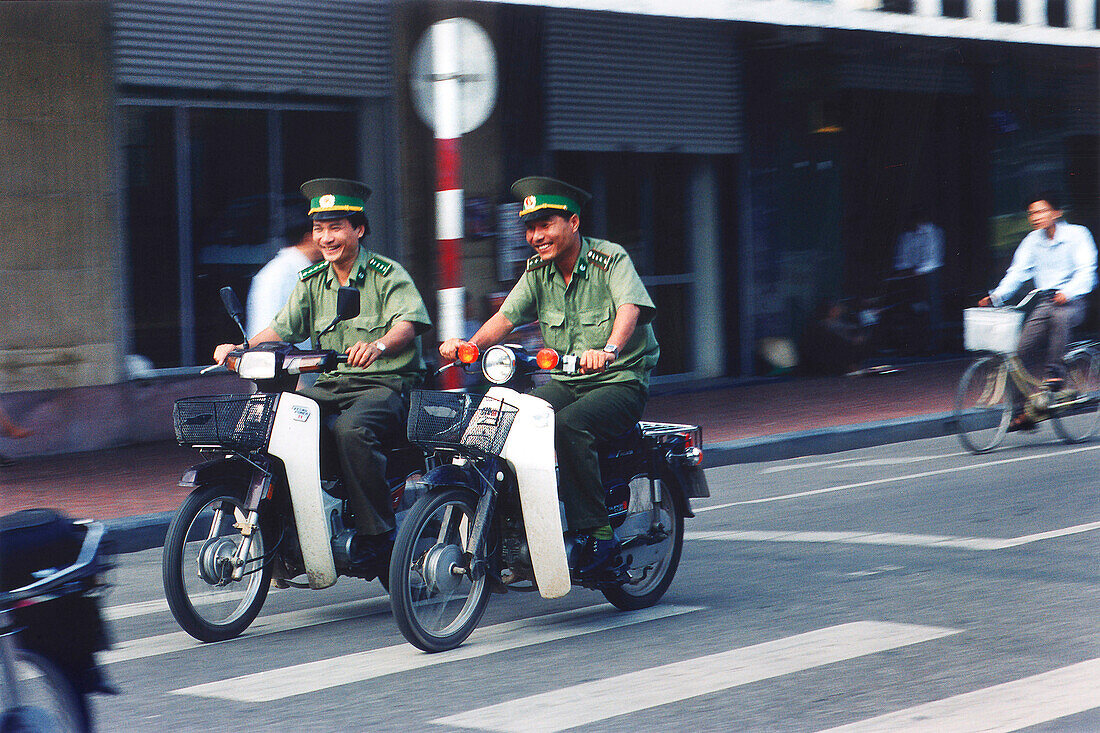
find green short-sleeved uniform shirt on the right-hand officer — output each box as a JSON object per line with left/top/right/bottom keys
{"left": 501, "top": 237, "right": 660, "bottom": 386}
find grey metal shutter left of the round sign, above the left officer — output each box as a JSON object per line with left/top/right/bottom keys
{"left": 112, "top": 0, "right": 391, "bottom": 98}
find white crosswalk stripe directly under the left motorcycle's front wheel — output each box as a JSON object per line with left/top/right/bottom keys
{"left": 96, "top": 597, "right": 389, "bottom": 665}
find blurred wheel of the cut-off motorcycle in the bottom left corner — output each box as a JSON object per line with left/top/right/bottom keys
{"left": 0, "top": 649, "right": 91, "bottom": 733}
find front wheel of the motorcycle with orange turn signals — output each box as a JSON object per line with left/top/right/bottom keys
{"left": 389, "top": 489, "right": 490, "bottom": 652}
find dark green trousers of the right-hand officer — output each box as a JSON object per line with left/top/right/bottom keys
{"left": 531, "top": 380, "right": 648, "bottom": 532}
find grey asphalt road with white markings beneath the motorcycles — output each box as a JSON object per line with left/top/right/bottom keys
{"left": 88, "top": 433, "right": 1100, "bottom": 732}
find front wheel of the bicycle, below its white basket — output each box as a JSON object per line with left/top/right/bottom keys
{"left": 955, "top": 357, "right": 1012, "bottom": 453}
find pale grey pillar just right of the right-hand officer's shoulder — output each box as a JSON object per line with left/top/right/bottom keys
{"left": 688, "top": 156, "right": 726, "bottom": 378}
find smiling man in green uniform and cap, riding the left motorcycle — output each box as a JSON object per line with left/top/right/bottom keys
{"left": 213, "top": 178, "right": 431, "bottom": 570}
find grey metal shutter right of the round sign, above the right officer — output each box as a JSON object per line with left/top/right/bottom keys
{"left": 545, "top": 10, "right": 741, "bottom": 154}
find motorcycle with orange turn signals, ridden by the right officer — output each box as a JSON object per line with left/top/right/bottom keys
{"left": 389, "top": 344, "right": 710, "bottom": 652}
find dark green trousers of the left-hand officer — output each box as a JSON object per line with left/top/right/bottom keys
{"left": 298, "top": 380, "right": 408, "bottom": 535}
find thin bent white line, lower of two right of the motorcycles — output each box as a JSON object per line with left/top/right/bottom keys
{"left": 684, "top": 522, "right": 1100, "bottom": 550}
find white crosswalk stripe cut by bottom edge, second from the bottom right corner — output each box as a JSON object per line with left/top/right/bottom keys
{"left": 431, "top": 621, "right": 961, "bottom": 733}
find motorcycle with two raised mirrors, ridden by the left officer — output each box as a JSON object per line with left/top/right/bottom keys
{"left": 162, "top": 287, "right": 426, "bottom": 642}
